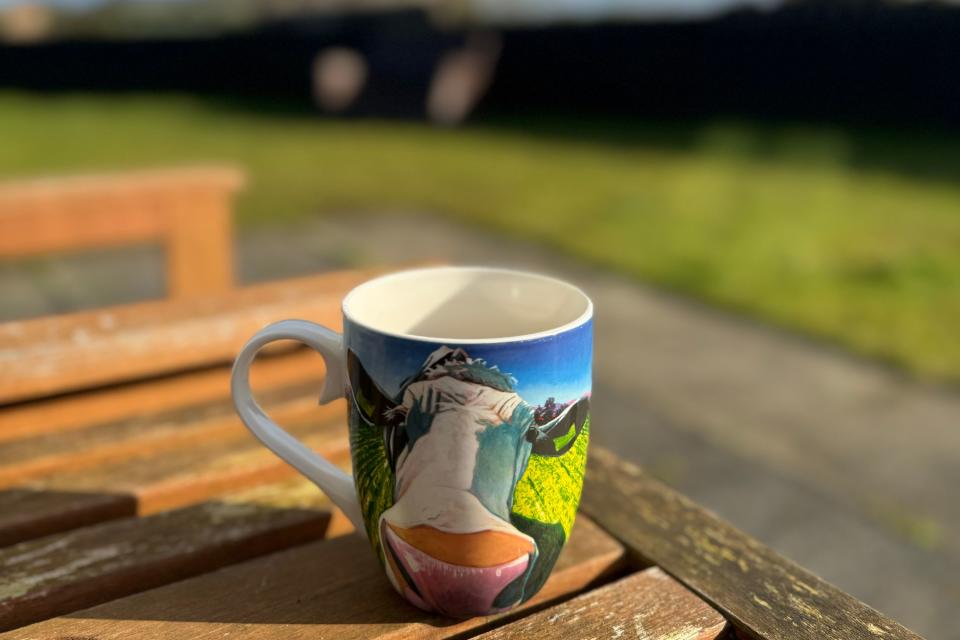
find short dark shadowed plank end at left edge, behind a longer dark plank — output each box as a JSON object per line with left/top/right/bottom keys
{"left": 0, "top": 489, "right": 137, "bottom": 547}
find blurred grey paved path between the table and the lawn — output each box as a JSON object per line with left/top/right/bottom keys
{"left": 0, "top": 216, "right": 960, "bottom": 639}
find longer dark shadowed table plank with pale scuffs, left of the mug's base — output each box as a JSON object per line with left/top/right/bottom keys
{"left": 0, "top": 502, "right": 329, "bottom": 630}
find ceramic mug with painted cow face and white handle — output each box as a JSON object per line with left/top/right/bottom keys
{"left": 232, "top": 267, "right": 593, "bottom": 617}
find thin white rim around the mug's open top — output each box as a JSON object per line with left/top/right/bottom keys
{"left": 340, "top": 266, "right": 593, "bottom": 345}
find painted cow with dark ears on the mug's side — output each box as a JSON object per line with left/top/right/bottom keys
{"left": 347, "top": 347, "right": 589, "bottom": 617}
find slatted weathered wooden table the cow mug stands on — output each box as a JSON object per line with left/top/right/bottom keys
{"left": 0, "top": 272, "right": 918, "bottom": 640}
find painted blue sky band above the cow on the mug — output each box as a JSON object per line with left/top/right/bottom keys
{"left": 347, "top": 321, "right": 593, "bottom": 405}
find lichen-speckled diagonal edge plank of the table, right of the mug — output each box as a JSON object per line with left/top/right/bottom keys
{"left": 581, "top": 447, "right": 920, "bottom": 640}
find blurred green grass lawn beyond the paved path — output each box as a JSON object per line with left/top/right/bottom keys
{"left": 0, "top": 93, "right": 960, "bottom": 381}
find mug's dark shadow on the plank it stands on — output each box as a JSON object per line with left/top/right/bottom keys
{"left": 65, "top": 533, "right": 480, "bottom": 637}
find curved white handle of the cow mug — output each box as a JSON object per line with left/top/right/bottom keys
{"left": 230, "top": 320, "right": 366, "bottom": 535}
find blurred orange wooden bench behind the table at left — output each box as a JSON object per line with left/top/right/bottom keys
{"left": 0, "top": 167, "right": 244, "bottom": 297}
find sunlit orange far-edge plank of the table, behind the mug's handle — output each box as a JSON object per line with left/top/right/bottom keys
{"left": 0, "top": 271, "right": 372, "bottom": 403}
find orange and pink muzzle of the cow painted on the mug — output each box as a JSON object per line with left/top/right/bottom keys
{"left": 381, "top": 519, "right": 536, "bottom": 618}
